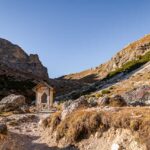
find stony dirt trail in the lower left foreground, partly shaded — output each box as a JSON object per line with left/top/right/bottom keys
{"left": 0, "top": 113, "right": 77, "bottom": 150}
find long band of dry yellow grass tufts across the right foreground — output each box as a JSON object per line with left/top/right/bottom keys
{"left": 47, "top": 107, "right": 150, "bottom": 148}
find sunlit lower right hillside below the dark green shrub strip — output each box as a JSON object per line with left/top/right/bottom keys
{"left": 89, "top": 62, "right": 150, "bottom": 103}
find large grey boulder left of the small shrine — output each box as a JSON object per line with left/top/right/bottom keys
{"left": 0, "top": 94, "right": 25, "bottom": 112}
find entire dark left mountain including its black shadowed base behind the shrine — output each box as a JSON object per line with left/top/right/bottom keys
{"left": 0, "top": 38, "right": 49, "bottom": 103}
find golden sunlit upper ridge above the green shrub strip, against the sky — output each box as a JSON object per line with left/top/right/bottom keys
{"left": 63, "top": 35, "right": 150, "bottom": 83}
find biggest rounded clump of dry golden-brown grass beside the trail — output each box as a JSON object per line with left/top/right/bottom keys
{"left": 57, "top": 111, "right": 101, "bottom": 143}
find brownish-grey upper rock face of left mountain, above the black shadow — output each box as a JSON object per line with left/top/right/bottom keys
{"left": 0, "top": 38, "right": 48, "bottom": 79}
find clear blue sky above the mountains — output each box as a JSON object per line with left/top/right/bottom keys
{"left": 0, "top": 0, "right": 150, "bottom": 77}
